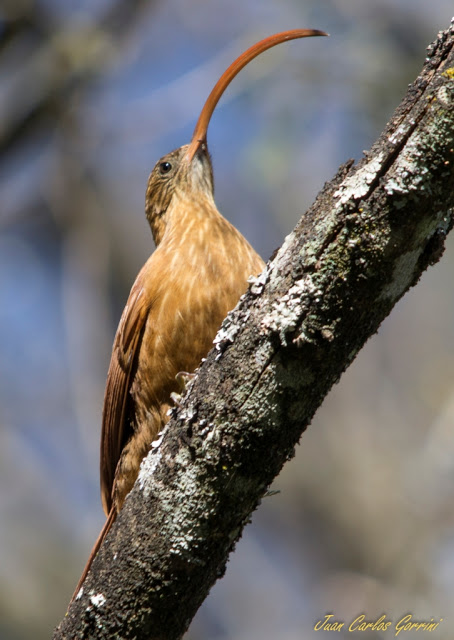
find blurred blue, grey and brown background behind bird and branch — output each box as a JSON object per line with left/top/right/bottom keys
{"left": 0, "top": 0, "right": 454, "bottom": 640}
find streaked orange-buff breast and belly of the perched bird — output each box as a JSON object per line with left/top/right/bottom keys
{"left": 131, "top": 219, "right": 263, "bottom": 424}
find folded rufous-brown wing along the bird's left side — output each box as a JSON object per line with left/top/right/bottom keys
{"left": 100, "top": 274, "right": 150, "bottom": 515}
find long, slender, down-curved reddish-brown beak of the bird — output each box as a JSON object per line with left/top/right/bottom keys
{"left": 186, "top": 29, "right": 328, "bottom": 162}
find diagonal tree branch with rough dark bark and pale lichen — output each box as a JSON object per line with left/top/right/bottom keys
{"left": 54, "top": 24, "right": 454, "bottom": 640}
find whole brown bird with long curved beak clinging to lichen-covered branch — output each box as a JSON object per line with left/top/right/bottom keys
{"left": 71, "top": 29, "right": 328, "bottom": 602}
